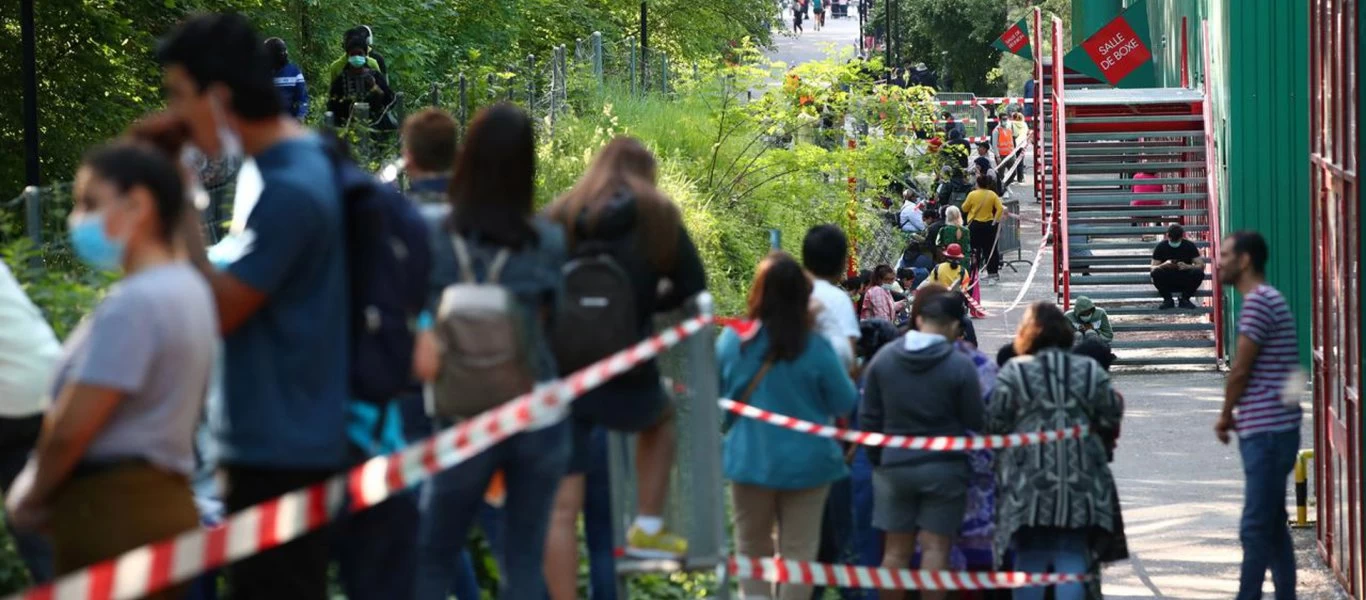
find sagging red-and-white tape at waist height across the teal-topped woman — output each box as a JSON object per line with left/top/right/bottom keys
{"left": 720, "top": 398, "right": 1089, "bottom": 451}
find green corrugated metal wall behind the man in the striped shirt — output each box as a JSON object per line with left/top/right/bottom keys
{"left": 1120, "top": 0, "right": 1313, "bottom": 368}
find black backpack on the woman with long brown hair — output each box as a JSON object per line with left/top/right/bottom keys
{"left": 550, "top": 206, "right": 642, "bottom": 376}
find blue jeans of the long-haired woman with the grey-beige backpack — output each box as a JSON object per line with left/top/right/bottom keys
{"left": 414, "top": 421, "right": 570, "bottom": 600}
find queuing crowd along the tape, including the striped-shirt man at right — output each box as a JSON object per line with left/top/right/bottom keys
{"left": 0, "top": 8, "right": 1299, "bottom": 600}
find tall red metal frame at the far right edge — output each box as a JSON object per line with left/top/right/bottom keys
{"left": 1309, "top": 0, "right": 1363, "bottom": 599}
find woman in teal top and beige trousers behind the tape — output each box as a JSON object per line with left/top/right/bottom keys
{"left": 716, "top": 253, "right": 858, "bottom": 600}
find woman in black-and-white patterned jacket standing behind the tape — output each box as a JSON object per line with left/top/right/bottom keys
{"left": 986, "top": 302, "right": 1121, "bottom": 600}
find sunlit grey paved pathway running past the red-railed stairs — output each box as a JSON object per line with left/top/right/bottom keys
{"left": 772, "top": 28, "right": 1346, "bottom": 600}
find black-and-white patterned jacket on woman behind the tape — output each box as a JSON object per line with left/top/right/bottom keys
{"left": 986, "top": 349, "right": 1123, "bottom": 563}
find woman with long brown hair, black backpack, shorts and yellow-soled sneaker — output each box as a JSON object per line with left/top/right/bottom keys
{"left": 546, "top": 138, "right": 706, "bottom": 600}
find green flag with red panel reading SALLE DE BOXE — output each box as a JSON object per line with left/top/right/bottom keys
{"left": 1063, "top": 0, "right": 1157, "bottom": 87}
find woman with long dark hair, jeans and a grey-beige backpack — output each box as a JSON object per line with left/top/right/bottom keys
{"left": 414, "top": 104, "right": 570, "bottom": 600}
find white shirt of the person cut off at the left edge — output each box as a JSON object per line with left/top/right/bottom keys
{"left": 0, "top": 262, "right": 61, "bottom": 417}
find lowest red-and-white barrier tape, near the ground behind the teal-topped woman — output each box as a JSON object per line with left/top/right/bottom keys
{"left": 728, "top": 556, "right": 1089, "bottom": 590}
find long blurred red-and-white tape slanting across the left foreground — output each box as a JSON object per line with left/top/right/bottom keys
{"left": 7, "top": 314, "right": 712, "bottom": 600}
